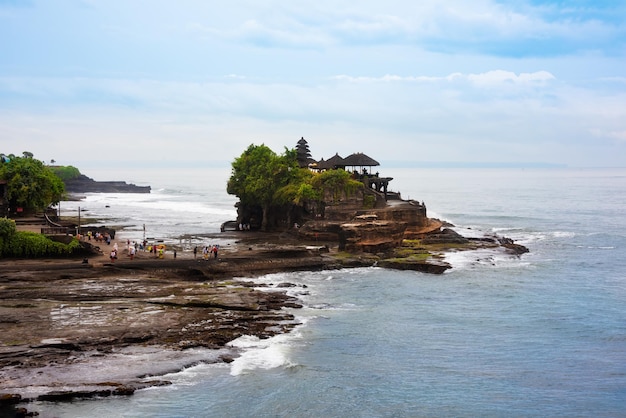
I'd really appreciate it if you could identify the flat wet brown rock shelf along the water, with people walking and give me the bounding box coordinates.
[0,230,527,414]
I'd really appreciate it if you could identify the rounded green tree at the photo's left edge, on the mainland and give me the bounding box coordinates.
[0,152,65,211]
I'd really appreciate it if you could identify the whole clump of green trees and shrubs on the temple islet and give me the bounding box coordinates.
[226,144,363,231]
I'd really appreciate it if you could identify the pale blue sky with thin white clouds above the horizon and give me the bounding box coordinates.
[0,0,626,168]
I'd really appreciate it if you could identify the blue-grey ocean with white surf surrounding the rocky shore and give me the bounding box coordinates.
[27,167,626,418]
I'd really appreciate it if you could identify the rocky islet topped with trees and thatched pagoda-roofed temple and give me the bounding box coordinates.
[222,138,528,274]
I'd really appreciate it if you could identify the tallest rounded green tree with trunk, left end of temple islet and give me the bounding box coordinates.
[226,144,299,231]
